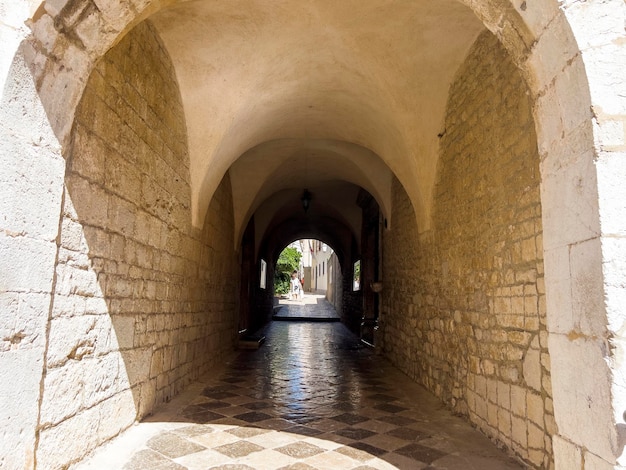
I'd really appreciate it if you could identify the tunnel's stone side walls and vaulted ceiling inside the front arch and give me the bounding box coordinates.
[31,0,553,465]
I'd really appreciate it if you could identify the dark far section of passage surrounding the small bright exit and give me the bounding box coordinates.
[240,182,383,341]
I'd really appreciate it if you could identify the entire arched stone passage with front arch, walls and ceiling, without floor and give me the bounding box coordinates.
[0,0,626,468]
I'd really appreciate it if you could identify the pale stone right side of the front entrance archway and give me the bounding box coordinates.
[468,2,624,469]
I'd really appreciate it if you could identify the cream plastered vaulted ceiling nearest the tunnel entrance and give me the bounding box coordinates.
[150,0,484,238]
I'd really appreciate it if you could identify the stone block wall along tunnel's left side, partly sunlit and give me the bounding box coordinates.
[36,22,239,469]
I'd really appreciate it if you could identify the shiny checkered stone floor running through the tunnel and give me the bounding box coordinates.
[80,304,523,470]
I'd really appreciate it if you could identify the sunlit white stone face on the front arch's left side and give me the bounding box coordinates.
[0,53,65,469]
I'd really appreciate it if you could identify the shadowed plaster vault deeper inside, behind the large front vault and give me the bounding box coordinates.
[229,139,391,248]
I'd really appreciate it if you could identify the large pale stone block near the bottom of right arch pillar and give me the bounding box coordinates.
[549,334,617,462]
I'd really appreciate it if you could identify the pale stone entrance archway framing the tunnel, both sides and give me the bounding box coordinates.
[0,0,626,468]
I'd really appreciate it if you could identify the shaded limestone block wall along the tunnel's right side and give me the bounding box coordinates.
[383,32,556,468]
